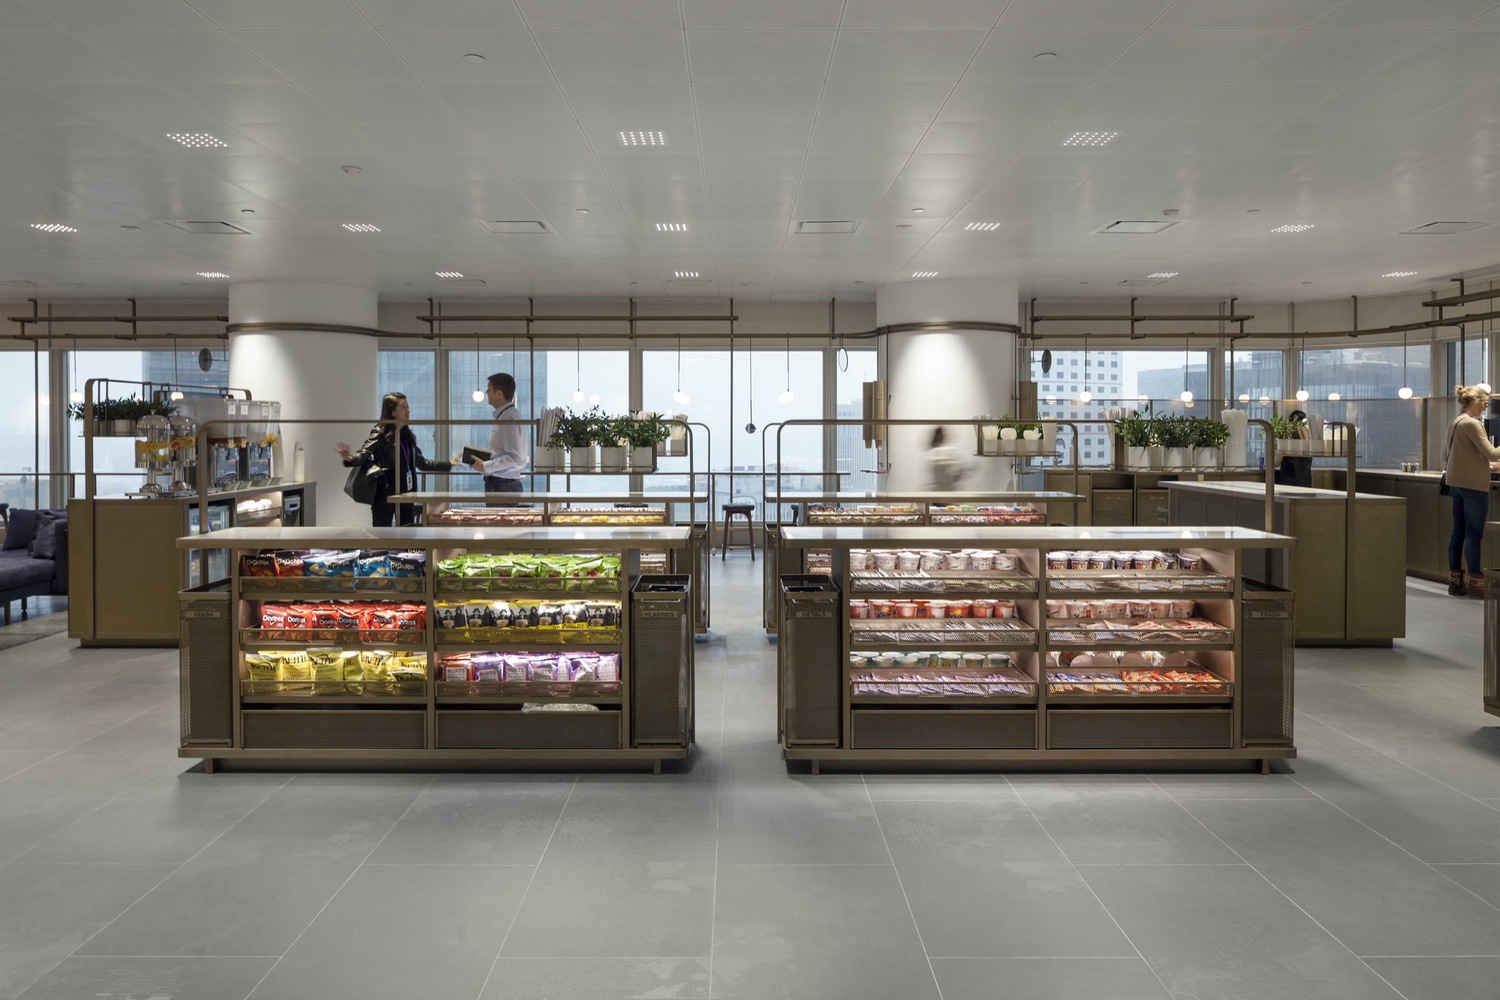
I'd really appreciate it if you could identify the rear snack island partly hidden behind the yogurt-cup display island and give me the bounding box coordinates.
[762,490,1079,633]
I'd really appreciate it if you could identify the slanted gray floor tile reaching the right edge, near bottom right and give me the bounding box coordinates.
[1188,801,1500,955]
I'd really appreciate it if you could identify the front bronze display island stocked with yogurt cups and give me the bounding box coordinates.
[777,526,1296,771]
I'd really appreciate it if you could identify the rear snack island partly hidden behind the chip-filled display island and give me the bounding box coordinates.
[395,492,713,634]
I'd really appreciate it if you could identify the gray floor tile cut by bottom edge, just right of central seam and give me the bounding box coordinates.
[713,867,938,1000]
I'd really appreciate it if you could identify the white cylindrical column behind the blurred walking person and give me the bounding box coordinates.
[875,277,1017,492]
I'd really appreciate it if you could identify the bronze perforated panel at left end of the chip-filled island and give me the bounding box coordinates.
[177,592,234,747]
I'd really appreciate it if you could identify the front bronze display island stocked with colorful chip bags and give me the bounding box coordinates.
[177,526,693,771]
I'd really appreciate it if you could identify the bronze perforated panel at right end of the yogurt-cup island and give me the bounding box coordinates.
[1236,591,1298,747]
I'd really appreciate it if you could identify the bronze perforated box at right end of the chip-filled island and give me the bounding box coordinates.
[630,576,693,747]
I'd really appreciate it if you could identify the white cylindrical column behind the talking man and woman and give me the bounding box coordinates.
[230,282,380,528]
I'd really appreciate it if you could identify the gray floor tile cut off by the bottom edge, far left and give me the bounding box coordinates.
[10,957,276,1000]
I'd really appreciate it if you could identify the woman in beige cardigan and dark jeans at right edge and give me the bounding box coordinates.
[1443,385,1500,598]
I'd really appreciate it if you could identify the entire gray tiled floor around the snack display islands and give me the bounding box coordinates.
[0,563,1500,1000]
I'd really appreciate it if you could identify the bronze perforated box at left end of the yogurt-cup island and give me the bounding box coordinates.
[776,576,845,747]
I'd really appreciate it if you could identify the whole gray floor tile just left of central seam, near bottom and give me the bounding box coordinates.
[501,844,714,958]
